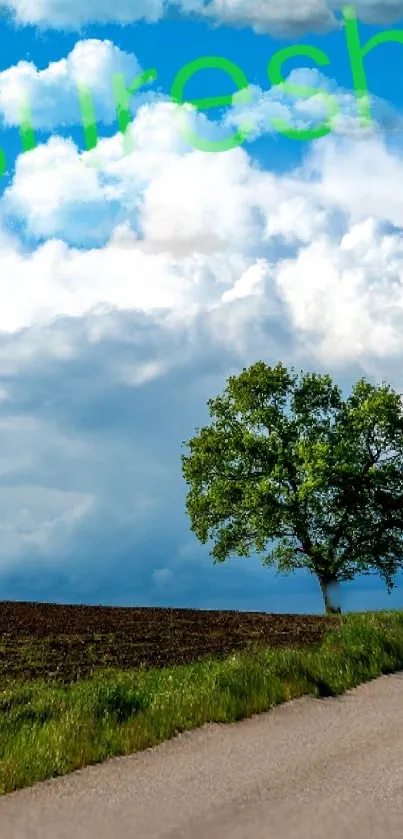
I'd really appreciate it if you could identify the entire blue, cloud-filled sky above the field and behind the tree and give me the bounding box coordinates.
[0,0,403,613]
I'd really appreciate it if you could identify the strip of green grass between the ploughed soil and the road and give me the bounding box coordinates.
[0,611,403,794]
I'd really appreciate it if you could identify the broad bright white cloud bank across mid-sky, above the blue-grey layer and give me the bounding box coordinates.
[0,94,403,364]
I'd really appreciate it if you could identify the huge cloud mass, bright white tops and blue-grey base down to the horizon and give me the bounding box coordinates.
[0,77,403,608]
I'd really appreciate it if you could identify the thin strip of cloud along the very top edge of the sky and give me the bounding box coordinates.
[1,0,403,37]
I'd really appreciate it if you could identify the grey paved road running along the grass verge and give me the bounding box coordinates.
[0,673,403,839]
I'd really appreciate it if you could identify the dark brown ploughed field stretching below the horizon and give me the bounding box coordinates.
[0,601,340,685]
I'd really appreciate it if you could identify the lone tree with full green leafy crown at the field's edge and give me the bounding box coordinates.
[181,361,403,613]
